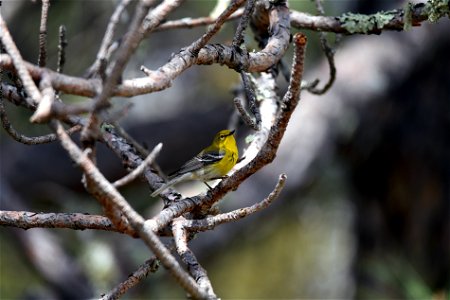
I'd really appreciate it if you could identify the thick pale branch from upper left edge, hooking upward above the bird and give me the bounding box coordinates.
[0,0,290,97]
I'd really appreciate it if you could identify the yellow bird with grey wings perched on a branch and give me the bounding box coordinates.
[152,130,239,197]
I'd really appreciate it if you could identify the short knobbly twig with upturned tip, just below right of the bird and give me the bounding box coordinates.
[184,174,286,232]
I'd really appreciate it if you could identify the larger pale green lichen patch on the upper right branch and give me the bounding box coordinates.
[338,10,396,33]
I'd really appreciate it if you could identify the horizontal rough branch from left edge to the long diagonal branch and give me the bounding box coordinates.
[0,211,123,233]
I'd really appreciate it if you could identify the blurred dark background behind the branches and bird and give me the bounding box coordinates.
[0,0,450,299]
